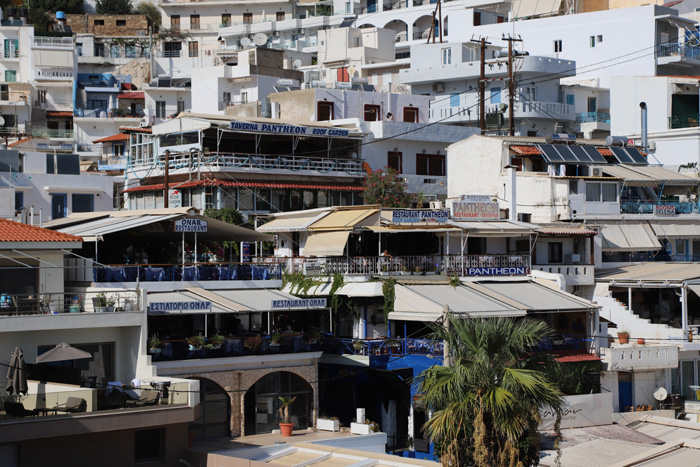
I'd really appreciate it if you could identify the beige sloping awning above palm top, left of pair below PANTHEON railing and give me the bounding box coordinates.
[389,285,526,322]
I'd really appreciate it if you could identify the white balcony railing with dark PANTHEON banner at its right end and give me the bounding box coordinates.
[274,254,530,276]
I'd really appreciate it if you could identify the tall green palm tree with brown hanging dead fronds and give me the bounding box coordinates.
[416,315,563,467]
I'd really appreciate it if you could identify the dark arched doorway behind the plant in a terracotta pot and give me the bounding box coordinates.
[244,371,314,435]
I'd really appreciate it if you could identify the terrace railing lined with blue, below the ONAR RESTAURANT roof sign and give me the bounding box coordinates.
[93,263,282,282]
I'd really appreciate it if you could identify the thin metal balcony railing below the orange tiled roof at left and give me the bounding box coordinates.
[0,290,142,317]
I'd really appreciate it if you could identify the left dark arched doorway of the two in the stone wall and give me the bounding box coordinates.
[190,378,231,439]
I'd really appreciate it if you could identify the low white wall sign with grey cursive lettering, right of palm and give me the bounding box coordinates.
[537,392,613,431]
